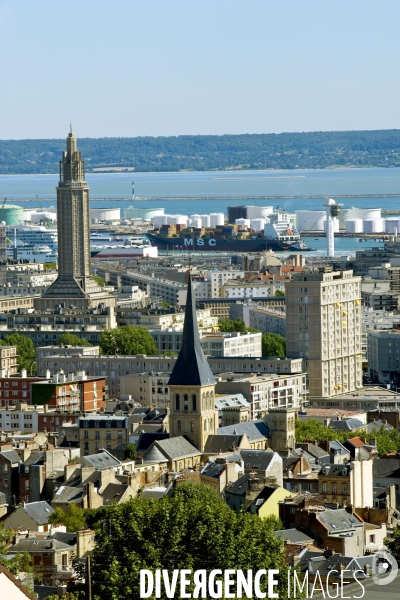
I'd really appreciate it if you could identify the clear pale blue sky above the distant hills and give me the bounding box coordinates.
[0,0,400,139]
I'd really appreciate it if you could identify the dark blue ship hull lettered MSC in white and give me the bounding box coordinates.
[146,233,293,252]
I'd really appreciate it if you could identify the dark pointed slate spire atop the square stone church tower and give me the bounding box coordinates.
[168,273,216,385]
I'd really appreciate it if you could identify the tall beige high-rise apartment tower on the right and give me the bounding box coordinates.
[286,271,362,397]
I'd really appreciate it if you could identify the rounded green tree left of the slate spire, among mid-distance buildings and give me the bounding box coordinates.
[100,325,158,356]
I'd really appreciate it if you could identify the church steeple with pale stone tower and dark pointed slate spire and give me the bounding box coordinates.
[168,274,217,452]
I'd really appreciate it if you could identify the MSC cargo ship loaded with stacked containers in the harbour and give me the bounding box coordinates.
[146,213,314,252]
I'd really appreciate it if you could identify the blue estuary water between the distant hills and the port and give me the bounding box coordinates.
[0,168,400,255]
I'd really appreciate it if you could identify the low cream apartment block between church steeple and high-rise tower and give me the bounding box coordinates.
[215,373,306,420]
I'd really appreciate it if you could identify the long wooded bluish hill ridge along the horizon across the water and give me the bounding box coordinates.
[0,129,400,174]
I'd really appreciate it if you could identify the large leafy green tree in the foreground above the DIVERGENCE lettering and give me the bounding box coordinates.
[88,482,288,600]
